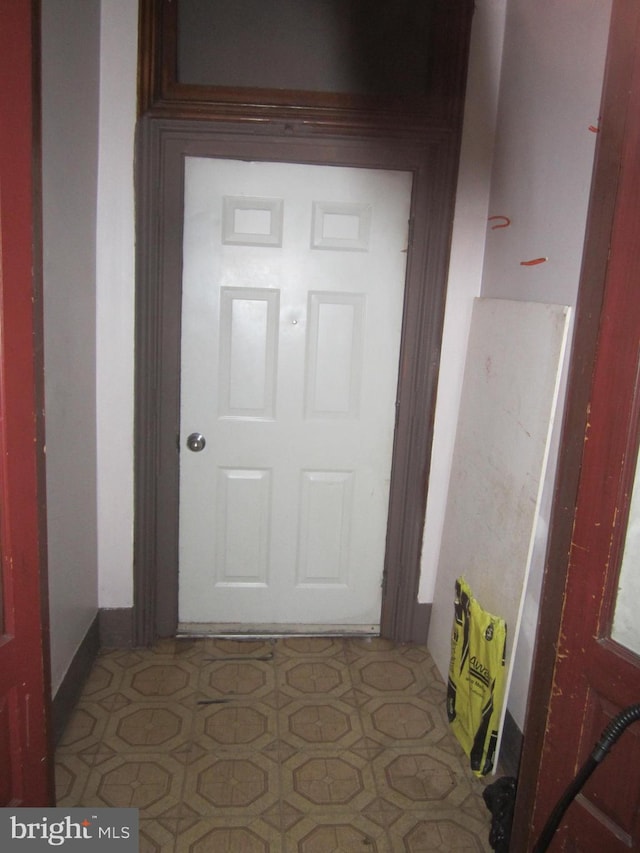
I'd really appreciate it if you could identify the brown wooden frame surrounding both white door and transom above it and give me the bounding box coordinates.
[134,0,474,644]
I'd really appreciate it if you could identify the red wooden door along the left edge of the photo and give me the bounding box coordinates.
[0,0,54,807]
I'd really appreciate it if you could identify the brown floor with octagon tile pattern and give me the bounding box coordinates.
[56,638,493,853]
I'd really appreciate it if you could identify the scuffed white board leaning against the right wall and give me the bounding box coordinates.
[429,298,570,764]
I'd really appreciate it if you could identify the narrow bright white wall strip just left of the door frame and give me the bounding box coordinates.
[96,0,138,608]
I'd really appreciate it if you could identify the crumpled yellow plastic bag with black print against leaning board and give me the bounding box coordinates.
[447,578,507,776]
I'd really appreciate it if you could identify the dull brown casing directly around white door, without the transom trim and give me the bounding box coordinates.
[135,118,459,644]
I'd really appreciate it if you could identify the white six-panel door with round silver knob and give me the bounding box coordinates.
[179,157,411,631]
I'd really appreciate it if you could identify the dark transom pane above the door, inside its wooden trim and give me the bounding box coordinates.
[173,0,434,98]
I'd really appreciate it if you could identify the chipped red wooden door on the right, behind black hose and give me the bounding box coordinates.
[516,0,640,851]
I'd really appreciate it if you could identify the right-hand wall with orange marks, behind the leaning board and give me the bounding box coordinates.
[424,0,610,728]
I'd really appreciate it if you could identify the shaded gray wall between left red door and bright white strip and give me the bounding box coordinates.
[42,0,100,694]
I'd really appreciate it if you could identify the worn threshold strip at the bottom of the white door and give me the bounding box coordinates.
[176,622,380,640]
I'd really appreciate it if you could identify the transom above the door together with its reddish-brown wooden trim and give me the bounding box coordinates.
[140,0,473,130]
